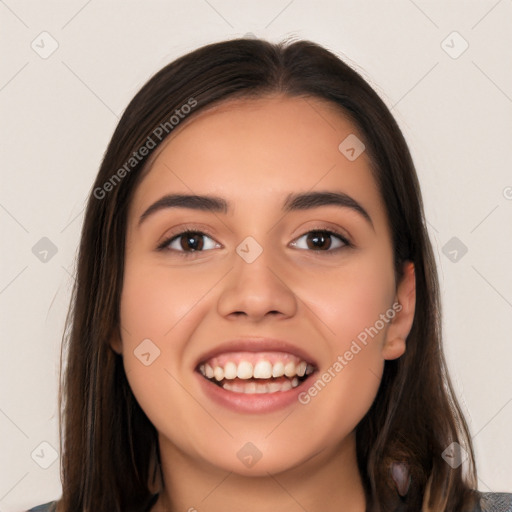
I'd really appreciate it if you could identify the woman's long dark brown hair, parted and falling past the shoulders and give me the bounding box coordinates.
[58,39,477,512]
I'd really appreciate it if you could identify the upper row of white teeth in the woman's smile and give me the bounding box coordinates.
[199,360,313,381]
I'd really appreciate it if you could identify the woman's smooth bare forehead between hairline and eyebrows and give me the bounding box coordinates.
[128,96,382,223]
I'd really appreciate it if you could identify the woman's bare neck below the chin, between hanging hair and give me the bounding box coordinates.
[151,433,366,512]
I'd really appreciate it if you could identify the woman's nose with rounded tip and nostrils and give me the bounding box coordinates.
[218,242,297,322]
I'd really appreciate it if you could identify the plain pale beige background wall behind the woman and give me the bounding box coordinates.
[0,0,512,512]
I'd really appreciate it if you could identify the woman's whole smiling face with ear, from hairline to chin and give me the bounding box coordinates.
[112,97,414,475]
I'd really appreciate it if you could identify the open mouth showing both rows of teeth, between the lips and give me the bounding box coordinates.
[197,352,316,394]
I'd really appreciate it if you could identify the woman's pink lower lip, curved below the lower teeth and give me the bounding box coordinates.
[197,372,313,414]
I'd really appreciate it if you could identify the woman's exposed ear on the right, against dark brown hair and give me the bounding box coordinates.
[382,261,416,359]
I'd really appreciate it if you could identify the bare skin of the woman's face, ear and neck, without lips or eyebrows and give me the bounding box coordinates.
[112,96,415,512]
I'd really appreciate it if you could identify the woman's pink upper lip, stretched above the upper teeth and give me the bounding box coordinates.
[196,337,317,369]
